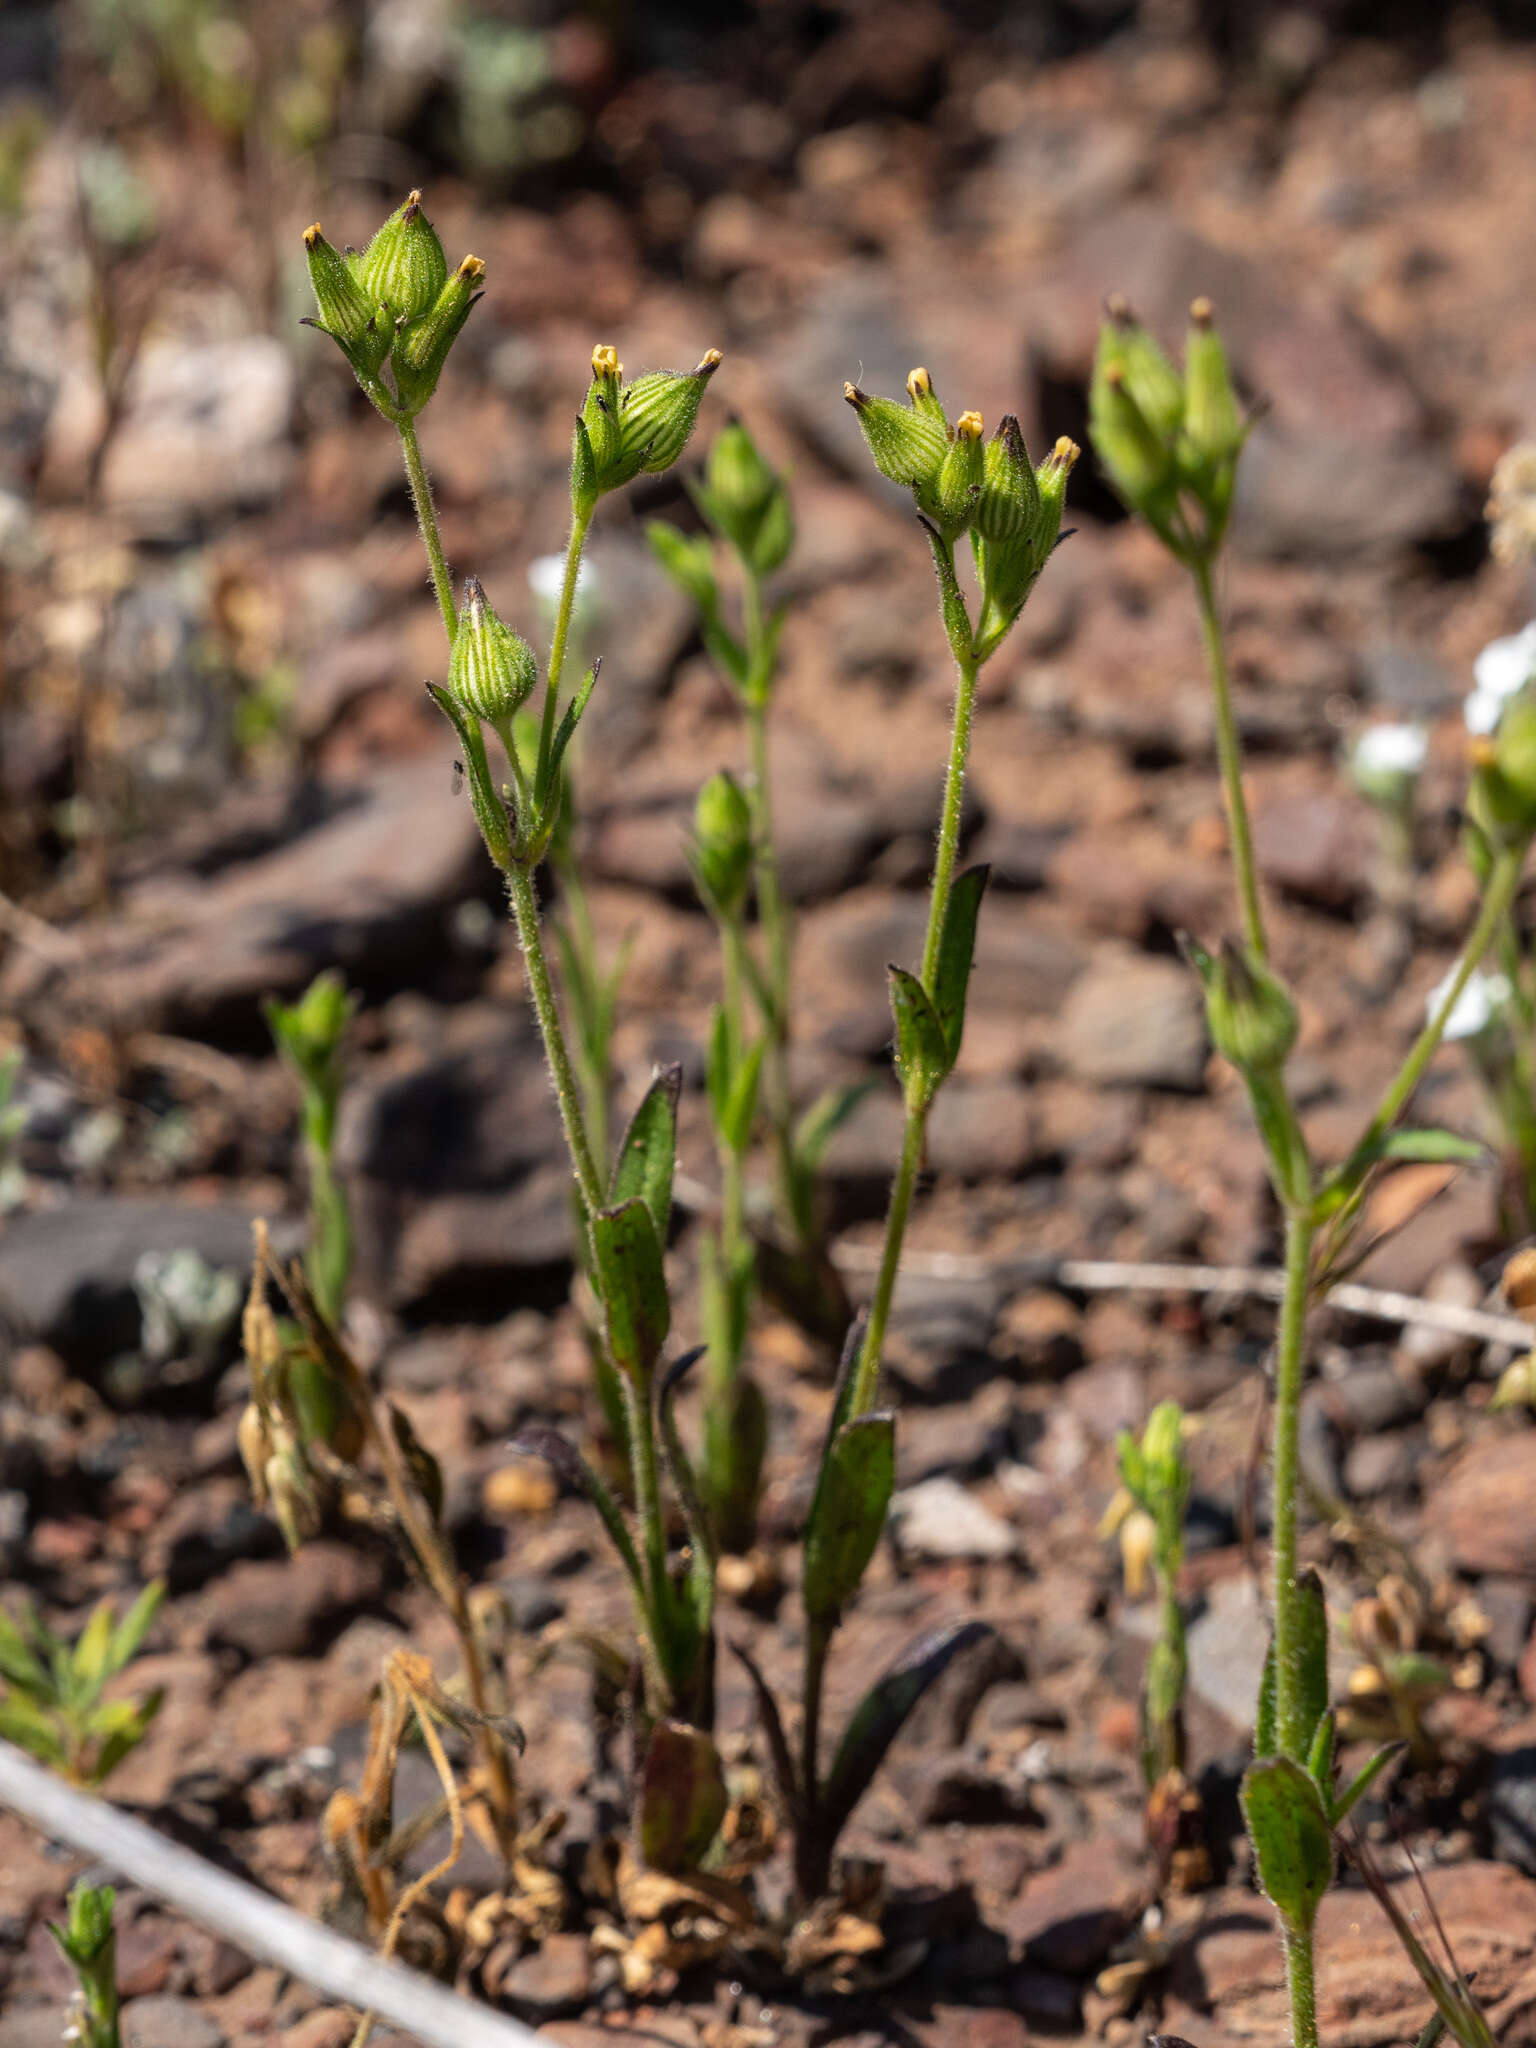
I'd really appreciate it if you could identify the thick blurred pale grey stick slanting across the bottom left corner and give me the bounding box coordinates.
[0,1741,547,2048]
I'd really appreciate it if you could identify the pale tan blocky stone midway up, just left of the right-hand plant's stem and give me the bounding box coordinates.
[1055,952,1206,1092]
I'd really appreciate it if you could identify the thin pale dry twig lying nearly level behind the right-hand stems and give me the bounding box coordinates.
[836,1245,1536,1350]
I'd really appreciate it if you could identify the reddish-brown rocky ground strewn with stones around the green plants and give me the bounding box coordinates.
[0,0,1536,2048]
